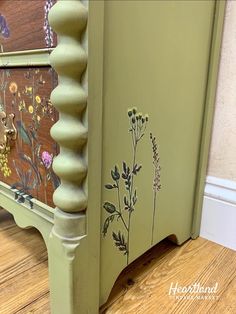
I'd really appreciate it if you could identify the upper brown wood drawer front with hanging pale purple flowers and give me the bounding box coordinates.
[0,0,56,52]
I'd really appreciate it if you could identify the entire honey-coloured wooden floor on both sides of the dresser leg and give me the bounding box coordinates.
[0,210,236,314]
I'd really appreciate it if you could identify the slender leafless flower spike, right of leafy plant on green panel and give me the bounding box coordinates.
[150,133,161,244]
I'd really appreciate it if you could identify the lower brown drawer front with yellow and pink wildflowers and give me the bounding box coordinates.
[0,67,59,207]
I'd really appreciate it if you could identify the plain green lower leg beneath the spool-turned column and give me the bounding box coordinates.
[48,210,99,314]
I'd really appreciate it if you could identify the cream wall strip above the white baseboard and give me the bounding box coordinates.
[208,0,236,181]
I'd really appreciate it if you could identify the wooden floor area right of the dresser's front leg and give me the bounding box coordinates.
[100,238,236,314]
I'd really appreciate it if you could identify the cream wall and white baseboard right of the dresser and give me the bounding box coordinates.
[200,0,236,250]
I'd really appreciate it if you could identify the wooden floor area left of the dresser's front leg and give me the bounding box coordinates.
[0,209,50,314]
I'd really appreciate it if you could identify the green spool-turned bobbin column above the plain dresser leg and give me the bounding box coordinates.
[49,0,88,213]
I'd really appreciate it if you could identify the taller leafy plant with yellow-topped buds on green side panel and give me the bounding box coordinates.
[102,108,148,264]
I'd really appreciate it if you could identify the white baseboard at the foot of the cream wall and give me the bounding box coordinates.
[200,177,236,250]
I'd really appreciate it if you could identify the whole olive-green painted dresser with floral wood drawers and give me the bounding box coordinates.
[0,0,225,314]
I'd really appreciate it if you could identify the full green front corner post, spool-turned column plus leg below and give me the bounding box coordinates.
[48,0,99,314]
